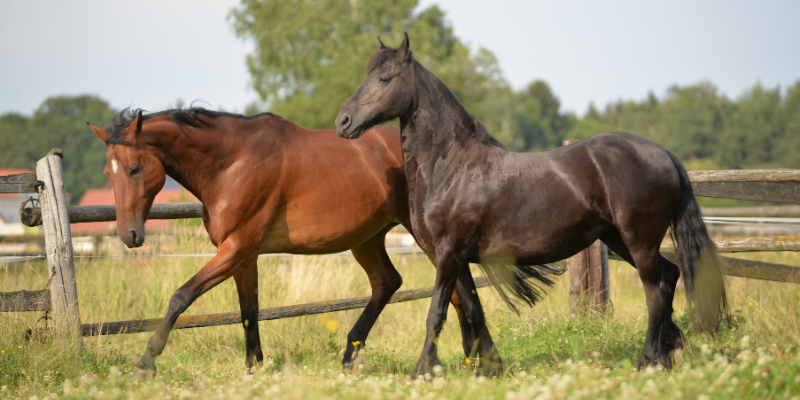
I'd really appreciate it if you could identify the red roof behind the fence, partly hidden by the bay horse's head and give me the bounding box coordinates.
[70,189,197,234]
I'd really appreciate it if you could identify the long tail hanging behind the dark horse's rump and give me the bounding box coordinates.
[667,151,728,332]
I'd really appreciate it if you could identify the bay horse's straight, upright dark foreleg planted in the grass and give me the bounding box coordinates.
[233,262,264,370]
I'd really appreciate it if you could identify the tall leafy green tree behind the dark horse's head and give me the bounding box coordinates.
[229,0,510,138]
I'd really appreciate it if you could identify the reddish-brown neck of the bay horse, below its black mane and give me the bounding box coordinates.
[142,120,233,201]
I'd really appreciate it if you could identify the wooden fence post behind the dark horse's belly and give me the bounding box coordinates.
[564,140,610,314]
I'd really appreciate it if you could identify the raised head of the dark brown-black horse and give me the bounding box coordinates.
[336,33,415,139]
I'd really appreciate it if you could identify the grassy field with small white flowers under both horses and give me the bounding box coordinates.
[0,228,800,399]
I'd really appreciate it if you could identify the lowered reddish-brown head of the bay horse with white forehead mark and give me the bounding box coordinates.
[89,110,166,247]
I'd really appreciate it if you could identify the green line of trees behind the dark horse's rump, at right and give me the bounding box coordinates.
[567,82,800,168]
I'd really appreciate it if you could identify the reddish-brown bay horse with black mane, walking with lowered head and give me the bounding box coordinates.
[90,108,500,373]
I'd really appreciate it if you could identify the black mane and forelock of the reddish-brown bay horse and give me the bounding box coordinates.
[106,107,280,145]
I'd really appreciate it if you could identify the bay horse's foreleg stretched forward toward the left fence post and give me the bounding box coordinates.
[136,237,257,374]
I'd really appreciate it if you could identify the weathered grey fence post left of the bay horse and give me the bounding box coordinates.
[36,149,83,348]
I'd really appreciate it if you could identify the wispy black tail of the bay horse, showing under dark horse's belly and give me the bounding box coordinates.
[478,264,564,315]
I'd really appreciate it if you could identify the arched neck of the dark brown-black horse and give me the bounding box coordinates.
[400,62,490,173]
